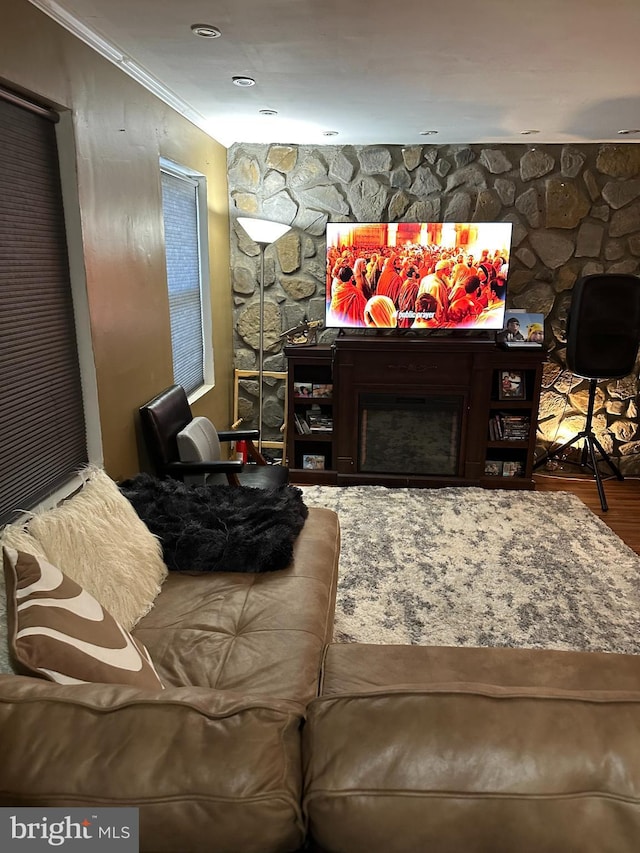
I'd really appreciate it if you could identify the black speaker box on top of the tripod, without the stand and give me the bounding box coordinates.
[567,273,640,379]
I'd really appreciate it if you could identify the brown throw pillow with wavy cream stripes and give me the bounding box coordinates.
[3,548,163,690]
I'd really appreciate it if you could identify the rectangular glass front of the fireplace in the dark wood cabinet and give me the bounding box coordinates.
[358,394,464,477]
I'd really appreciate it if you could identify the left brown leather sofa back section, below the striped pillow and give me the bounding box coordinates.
[0,676,304,853]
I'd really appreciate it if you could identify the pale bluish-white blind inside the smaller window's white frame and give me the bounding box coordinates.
[162,172,204,393]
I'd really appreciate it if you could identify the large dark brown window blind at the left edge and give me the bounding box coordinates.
[0,91,87,524]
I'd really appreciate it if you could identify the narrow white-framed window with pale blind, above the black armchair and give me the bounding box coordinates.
[160,160,213,394]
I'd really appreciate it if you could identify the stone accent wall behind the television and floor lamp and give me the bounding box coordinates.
[228,143,640,474]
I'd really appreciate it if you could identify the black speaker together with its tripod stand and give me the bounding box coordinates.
[533,274,640,512]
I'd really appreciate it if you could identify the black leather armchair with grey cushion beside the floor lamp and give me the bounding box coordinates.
[140,385,289,489]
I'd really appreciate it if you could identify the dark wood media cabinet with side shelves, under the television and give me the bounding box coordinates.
[285,335,545,489]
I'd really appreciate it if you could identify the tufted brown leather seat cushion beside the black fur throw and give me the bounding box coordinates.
[134,507,340,704]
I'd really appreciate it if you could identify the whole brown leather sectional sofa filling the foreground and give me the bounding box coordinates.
[0,470,640,853]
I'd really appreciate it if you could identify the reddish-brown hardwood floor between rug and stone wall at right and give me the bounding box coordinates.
[534,473,640,554]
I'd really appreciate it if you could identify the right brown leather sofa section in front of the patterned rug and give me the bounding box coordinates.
[303,643,640,853]
